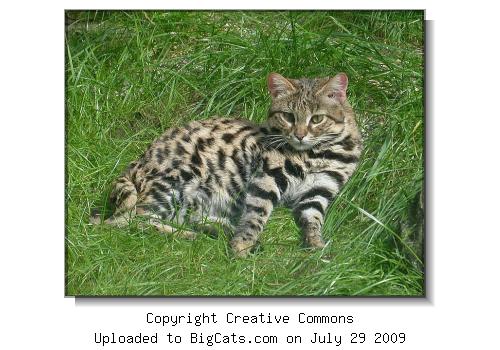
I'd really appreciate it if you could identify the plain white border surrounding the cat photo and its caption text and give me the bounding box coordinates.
[0,0,500,349]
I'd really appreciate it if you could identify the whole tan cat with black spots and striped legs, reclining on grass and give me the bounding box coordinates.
[92,73,362,256]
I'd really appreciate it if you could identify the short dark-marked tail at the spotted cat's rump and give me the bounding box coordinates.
[90,174,137,226]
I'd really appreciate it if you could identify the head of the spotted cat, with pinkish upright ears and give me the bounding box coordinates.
[267,73,351,151]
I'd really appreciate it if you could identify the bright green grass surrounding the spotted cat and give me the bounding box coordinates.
[65,11,424,296]
